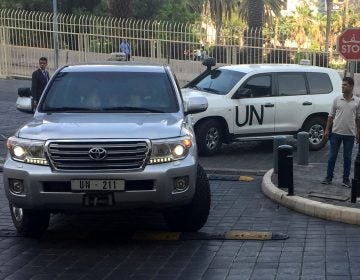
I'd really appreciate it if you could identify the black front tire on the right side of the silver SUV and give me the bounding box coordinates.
[163,165,211,232]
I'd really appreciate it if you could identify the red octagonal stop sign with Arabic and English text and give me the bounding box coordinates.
[336,28,360,60]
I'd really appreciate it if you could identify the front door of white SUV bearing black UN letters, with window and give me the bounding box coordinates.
[233,73,275,136]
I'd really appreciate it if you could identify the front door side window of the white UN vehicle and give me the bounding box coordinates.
[241,74,272,98]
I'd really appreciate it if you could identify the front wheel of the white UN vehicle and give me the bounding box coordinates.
[195,119,223,156]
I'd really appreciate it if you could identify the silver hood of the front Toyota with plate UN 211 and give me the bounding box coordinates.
[17,113,183,140]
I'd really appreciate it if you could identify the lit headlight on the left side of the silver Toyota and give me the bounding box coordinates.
[6,137,49,165]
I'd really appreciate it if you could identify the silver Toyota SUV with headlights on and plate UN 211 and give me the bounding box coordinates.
[3,63,210,236]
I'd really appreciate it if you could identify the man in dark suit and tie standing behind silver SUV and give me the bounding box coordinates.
[31,57,50,107]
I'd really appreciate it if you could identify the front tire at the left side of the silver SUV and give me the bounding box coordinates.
[9,204,50,237]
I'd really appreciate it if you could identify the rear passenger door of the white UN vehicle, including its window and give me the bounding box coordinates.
[275,72,315,133]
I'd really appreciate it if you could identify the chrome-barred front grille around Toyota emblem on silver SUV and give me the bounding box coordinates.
[47,140,150,171]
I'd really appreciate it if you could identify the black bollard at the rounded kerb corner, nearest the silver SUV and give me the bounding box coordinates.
[278,145,294,196]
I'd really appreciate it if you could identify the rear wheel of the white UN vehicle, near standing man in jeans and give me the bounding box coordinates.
[302,117,326,151]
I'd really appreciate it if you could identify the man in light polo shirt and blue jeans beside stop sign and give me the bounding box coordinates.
[321,77,360,188]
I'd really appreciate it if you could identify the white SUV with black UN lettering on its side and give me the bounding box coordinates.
[182,58,341,156]
